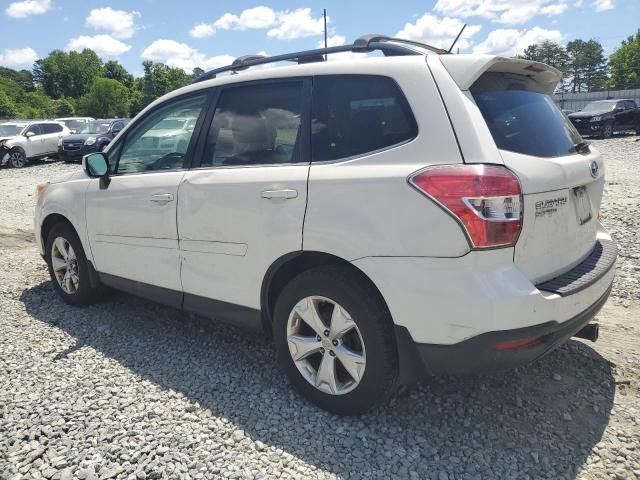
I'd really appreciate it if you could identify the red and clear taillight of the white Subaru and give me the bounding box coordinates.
[409,164,522,248]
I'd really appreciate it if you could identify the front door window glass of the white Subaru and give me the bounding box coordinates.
[116,95,207,175]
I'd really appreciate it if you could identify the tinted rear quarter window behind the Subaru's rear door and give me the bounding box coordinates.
[311,75,418,162]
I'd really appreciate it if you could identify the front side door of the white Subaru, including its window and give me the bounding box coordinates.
[86,94,207,296]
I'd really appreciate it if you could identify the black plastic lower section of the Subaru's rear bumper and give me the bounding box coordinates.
[403,288,611,376]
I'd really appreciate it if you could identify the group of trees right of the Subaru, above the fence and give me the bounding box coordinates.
[520,30,640,93]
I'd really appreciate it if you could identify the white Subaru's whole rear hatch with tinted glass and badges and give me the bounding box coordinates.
[471,72,604,283]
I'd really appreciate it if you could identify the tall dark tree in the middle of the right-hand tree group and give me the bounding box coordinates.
[567,39,607,93]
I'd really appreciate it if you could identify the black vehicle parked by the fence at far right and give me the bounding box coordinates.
[567,99,640,138]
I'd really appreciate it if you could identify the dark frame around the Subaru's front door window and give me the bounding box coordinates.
[108,87,215,177]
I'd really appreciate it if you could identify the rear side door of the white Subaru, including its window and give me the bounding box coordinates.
[178,79,310,321]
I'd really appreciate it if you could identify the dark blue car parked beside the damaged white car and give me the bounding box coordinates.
[58,118,129,162]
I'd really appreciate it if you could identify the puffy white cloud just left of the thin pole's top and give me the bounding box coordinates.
[189,6,330,40]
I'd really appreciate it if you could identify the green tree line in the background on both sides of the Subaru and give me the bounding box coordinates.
[0,30,640,118]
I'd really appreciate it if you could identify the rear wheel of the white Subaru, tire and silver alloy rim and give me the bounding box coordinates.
[273,266,398,415]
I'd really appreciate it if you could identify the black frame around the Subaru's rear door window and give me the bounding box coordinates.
[189,77,312,170]
